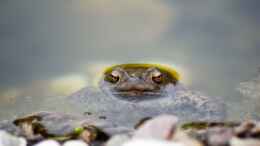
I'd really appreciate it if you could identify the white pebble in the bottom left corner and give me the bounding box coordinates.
[0,131,27,146]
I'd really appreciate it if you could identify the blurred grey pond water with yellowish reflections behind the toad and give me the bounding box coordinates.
[0,0,260,120]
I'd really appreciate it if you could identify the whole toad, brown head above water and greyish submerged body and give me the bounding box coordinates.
[69,64,225,125]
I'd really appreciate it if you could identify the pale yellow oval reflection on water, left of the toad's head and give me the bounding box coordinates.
[50,75,87,95]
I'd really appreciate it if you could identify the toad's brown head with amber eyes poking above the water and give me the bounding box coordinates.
[100,64,179,101]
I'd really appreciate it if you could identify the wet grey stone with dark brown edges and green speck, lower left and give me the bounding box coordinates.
[2,112,109,145]
